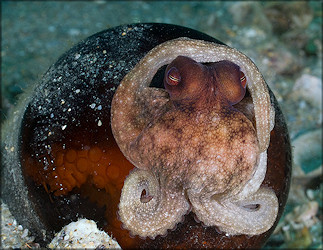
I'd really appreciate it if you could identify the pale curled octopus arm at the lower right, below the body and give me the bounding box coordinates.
[188,188,278,235]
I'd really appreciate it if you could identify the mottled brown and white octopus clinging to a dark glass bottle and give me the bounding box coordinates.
[111,38,278,239]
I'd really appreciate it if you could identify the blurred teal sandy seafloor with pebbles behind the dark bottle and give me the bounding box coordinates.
[1,1,322,249]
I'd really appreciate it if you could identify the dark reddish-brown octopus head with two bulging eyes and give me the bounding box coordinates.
[164,56,246,105]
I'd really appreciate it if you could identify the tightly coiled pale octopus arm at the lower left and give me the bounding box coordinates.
[119,169,190,239]
